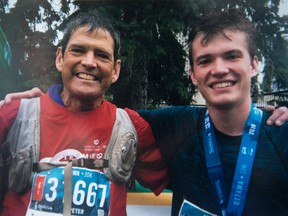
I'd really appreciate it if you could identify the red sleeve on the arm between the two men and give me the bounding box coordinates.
[125,108,169,195]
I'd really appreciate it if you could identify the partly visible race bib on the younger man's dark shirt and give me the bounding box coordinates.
[179,200,217,216]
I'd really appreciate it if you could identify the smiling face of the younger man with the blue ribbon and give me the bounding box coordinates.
[190,30,258,108]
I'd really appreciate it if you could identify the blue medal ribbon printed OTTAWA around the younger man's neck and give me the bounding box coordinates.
[203,105,262,216]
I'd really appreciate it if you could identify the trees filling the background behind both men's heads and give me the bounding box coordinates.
[0,0,288,109]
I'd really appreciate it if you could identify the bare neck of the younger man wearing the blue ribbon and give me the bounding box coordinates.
[207,102,251,136]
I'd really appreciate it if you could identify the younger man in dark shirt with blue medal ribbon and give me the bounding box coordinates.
[141,9,288,216]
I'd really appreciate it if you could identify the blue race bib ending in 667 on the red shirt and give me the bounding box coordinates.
[26,167,110,216]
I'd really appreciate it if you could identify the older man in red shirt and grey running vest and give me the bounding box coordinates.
[0,11,168,216]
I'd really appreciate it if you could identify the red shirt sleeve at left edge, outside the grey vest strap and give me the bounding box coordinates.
[0,100,20,145]
